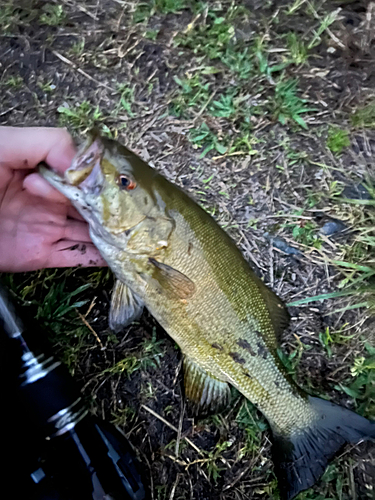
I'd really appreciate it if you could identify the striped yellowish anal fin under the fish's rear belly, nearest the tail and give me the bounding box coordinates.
[184,356,231,414]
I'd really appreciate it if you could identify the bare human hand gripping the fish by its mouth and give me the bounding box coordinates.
[0,127,107,272]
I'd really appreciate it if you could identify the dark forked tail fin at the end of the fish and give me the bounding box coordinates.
[272,397,375,500]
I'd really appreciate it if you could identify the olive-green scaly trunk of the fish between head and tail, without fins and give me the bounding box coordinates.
[117,197,314,433]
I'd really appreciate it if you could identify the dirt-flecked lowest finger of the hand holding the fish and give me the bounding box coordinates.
[45,240,107,267]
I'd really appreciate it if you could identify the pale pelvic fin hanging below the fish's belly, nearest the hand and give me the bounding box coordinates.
[109,280,144,333]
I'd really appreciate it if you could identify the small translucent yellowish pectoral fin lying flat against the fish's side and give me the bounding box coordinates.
[149,258,195,299]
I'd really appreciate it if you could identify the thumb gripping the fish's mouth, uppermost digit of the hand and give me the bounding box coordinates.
[0,127,76,172]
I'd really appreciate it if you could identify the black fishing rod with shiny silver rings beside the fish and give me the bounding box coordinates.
[0,288,146,500]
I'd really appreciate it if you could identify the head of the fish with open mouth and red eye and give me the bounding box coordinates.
[39,133,176,253]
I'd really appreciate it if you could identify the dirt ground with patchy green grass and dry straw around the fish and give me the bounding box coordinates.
[0,0,375,500]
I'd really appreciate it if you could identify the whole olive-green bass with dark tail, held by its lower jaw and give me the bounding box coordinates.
[39,133,375,500]
